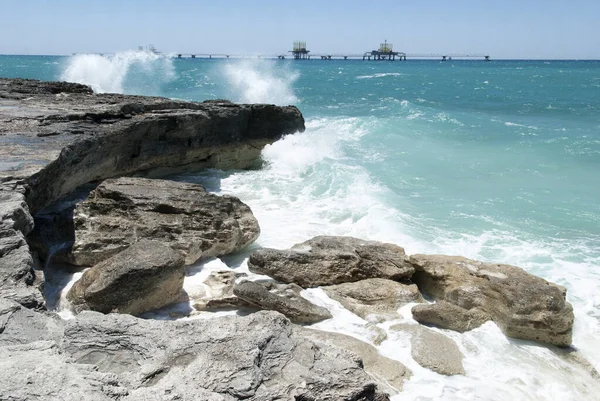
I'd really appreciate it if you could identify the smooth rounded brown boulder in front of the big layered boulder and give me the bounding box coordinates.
[67,240,185,315]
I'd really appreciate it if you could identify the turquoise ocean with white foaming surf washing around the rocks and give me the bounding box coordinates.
[0,52,600,401]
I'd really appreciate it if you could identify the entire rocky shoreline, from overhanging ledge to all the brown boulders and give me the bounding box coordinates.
[0,79,574,401]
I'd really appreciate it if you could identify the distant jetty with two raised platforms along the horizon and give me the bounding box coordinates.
[176,40,490,61]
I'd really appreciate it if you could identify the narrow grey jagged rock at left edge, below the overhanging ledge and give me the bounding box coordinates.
[0,189,44,309]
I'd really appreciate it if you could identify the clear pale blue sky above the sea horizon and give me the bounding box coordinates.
[0,0,600,59]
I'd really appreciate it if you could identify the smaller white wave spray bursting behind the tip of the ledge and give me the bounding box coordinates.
[223,60,299,106]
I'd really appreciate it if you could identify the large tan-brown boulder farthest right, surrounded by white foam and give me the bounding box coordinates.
[410,255,574,347]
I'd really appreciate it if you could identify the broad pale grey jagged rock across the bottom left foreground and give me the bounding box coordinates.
[0,302,388,401]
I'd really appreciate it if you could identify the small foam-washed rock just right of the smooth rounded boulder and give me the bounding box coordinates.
[193,270,248,311]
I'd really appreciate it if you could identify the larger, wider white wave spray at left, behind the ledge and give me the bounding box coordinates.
[61,51,175,94]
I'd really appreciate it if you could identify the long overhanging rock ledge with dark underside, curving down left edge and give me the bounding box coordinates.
[0,78,304,308]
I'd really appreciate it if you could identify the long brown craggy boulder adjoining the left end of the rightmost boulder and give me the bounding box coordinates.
[248,236,414,288]
